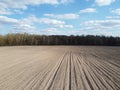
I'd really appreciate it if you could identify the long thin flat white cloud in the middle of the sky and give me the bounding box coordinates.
[44,13,79,19]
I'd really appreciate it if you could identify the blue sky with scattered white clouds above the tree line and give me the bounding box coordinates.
[0,0,120,36]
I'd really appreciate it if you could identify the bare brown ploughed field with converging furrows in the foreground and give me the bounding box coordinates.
[0,46,120,90]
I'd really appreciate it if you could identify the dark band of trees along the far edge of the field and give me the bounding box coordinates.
[0,33,120,46]
